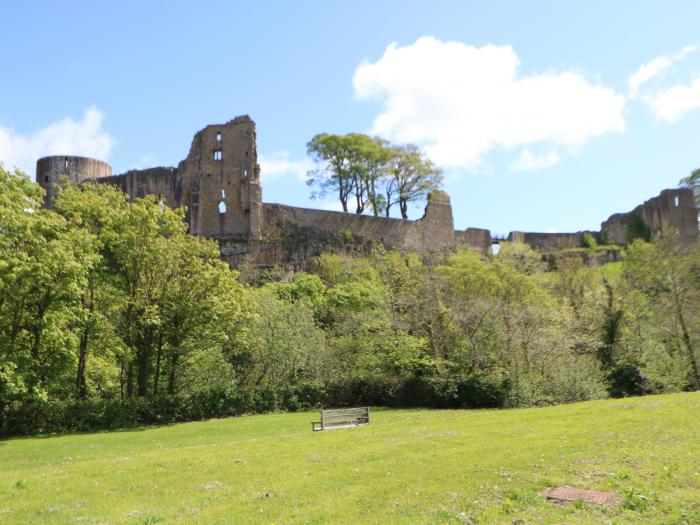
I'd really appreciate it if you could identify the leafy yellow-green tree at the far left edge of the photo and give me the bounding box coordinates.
[0,165,96,423]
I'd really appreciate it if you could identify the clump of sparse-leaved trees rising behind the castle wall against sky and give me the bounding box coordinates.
[307,133,442,219]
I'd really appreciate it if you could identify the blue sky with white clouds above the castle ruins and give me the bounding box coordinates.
[0,0,700,233]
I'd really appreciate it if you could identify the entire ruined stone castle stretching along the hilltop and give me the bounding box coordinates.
[36,116,698,268]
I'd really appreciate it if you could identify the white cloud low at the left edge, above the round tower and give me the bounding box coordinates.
[0,106,114,179]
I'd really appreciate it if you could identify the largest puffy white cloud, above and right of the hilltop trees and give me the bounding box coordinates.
[353,37,625,172]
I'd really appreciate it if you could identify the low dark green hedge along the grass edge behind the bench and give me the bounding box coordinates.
[0,376,508,437]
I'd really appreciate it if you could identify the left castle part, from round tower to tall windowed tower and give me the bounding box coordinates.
[36,116,262,242]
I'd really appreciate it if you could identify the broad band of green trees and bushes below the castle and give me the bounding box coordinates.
[0,169,700,435]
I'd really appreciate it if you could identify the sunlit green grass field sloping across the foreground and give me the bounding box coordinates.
[0,393,700,525]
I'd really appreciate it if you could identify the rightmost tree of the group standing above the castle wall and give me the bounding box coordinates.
[384,144,442,219]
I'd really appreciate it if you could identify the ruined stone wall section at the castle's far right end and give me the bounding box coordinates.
[601,188,698,246]
